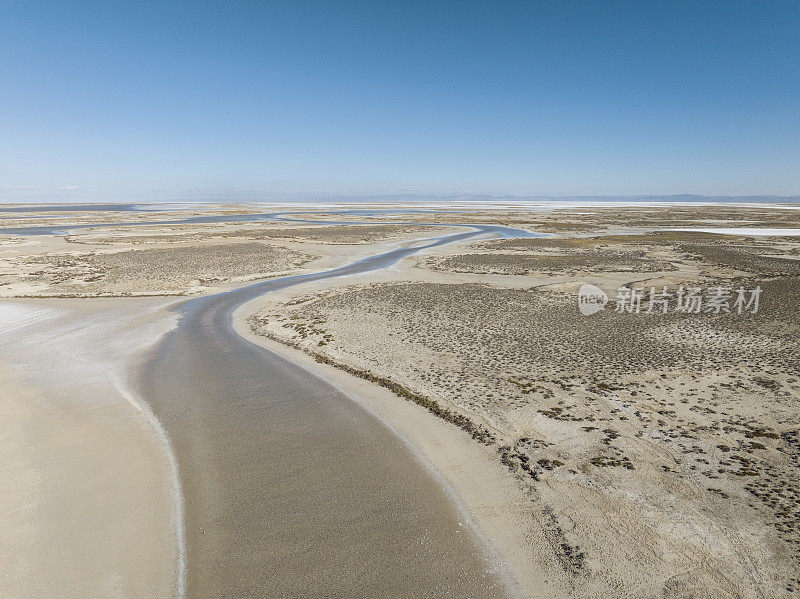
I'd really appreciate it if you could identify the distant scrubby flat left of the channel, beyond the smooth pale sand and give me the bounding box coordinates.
[0,212,441,297]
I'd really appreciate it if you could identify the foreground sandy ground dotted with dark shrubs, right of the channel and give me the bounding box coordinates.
[251,277,800,596]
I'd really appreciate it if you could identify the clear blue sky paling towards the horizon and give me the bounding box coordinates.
[0,0,800,201]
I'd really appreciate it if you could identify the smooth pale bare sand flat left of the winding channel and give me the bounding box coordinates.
[0,298,181,598]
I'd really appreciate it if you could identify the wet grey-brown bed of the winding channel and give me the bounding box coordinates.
[135,227,511,597]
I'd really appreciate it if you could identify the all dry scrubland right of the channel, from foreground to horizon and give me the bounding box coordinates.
[250,220,800,597]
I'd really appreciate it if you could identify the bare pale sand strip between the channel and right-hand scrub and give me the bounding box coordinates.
[235,322,569,599]
